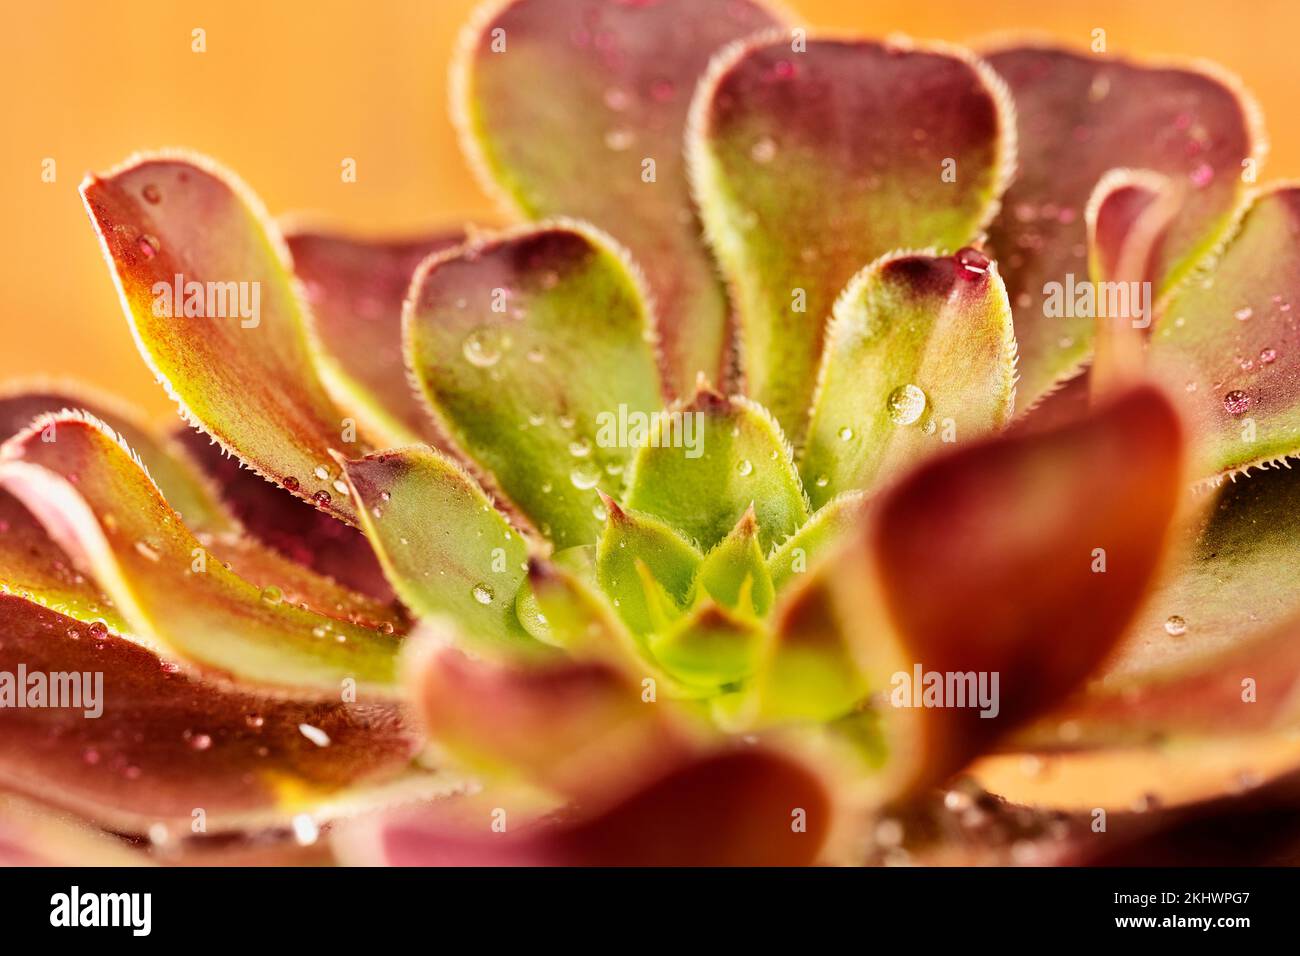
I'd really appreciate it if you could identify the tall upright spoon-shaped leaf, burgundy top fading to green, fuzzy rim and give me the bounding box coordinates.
[686,35,1014,444]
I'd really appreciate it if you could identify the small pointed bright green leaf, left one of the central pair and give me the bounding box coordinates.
[595,498,701,635]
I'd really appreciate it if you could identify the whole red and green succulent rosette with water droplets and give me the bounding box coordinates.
[0,0,1300,864]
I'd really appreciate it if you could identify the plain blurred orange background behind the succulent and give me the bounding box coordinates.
[0,0,1300,414]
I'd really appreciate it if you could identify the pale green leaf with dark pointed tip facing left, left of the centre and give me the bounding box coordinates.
[343,446,529,643]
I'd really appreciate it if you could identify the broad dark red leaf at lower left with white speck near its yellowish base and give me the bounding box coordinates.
[0,596,446,832]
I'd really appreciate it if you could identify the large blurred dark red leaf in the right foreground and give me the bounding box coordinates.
[857,386,1183,780]
